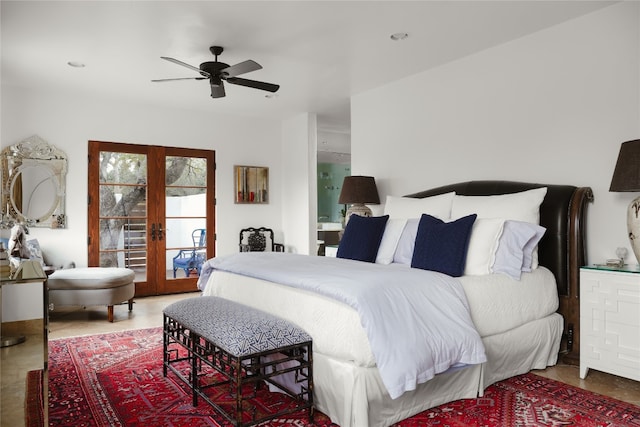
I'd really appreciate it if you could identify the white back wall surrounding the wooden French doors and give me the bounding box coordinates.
[0,86,284,266]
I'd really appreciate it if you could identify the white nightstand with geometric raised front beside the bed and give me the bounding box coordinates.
[580,265,640,381]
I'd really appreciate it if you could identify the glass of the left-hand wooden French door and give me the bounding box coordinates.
[99,151,147,281]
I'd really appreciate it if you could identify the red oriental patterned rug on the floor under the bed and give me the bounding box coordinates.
[26,328,640,427]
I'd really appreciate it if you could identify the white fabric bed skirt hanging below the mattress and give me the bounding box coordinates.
[313,314,562,427]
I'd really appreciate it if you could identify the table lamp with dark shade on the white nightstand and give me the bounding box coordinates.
[609,139,640,263]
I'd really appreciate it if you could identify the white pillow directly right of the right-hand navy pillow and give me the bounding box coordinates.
[464,218,504,275]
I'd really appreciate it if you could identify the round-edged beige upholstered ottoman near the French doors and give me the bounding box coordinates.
[47,267,136,322]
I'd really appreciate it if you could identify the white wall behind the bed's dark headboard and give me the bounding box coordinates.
[351,2,640,262]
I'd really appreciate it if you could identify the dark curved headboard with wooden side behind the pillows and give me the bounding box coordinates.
[407,181,593,364]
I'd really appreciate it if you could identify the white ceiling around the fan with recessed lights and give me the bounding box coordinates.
[0,0,612,137]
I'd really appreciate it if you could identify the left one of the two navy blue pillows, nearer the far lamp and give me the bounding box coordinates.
[336,215,389,262]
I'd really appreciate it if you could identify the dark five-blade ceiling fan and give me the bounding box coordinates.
[151,46,280,98]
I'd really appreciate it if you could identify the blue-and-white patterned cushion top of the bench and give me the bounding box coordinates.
[163,296,311,357]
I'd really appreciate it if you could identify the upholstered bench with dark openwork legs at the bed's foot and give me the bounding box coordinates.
[163,296,313,427]
